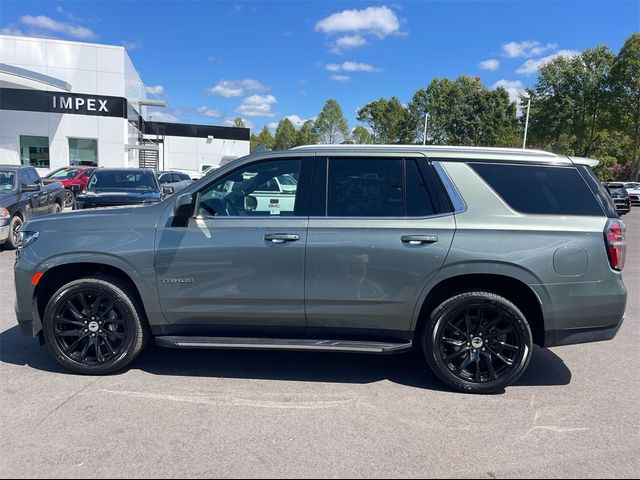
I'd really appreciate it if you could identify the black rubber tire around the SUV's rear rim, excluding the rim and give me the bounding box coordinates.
[422,292,533,393]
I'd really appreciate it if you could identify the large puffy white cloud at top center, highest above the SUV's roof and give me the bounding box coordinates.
[316,6,400,38]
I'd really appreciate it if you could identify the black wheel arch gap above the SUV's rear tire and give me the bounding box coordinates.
[414,273,545,346]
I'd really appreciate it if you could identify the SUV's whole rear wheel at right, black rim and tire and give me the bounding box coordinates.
[420,291,533,393]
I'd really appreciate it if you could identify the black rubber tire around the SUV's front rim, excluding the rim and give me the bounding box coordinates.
[43,279,140,375]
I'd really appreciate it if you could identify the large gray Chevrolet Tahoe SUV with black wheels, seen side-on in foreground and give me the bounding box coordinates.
[15,146,627,393]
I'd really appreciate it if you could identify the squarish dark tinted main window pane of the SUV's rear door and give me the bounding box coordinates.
[327,158,404,217]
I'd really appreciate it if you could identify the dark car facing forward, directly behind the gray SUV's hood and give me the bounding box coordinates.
[73,168,173,210]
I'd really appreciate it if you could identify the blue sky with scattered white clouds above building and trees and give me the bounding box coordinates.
[0,0,640,131]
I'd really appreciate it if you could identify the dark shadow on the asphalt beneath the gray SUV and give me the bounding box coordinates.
[0,326,571,391]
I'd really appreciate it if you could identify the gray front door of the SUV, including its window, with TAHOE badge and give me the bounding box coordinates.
[156,157,313,331]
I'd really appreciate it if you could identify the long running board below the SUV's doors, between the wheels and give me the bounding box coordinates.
[156,336,413,353]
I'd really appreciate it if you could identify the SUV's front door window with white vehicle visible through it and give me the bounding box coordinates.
[198,159,302,217]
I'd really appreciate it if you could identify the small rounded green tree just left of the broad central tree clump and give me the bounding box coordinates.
[358,97,415,144]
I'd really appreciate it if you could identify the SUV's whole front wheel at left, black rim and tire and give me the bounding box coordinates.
[43,277,148,375]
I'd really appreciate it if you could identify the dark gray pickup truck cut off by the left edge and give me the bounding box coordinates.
[0,165,64,249]
